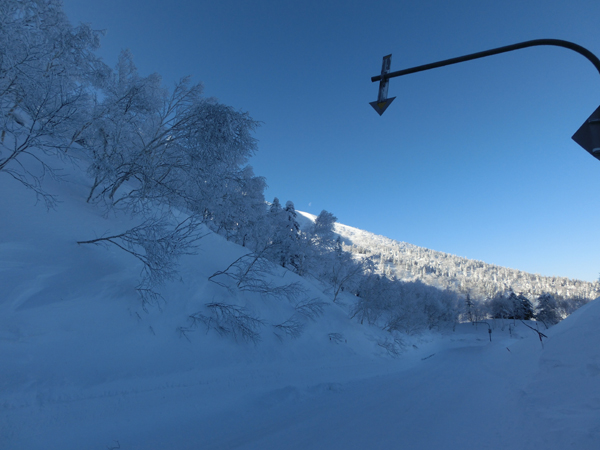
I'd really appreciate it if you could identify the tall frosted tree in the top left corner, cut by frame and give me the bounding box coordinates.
[0,0,107,207]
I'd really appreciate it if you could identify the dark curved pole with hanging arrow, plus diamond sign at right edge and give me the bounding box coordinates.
[371,39,600,160]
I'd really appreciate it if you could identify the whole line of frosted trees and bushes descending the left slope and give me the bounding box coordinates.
[0,0,584,345]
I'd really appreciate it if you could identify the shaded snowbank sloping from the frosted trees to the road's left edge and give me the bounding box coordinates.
[0,158,390,449]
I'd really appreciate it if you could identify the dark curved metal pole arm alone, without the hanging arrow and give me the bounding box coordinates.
[371,39,600,82]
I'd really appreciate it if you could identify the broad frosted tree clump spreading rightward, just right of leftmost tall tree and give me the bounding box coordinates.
[84,52,265,225]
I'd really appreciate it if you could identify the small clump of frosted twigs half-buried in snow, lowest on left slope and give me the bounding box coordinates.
[189,302,264,344]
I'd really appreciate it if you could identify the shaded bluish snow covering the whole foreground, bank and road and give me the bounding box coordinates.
[0,174,600,450]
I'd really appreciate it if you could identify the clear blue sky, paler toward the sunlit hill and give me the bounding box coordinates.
[64,0,600,281]
